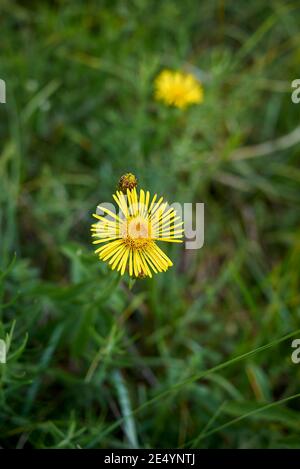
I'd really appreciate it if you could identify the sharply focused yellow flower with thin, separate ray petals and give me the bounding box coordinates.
[91,188,184,277]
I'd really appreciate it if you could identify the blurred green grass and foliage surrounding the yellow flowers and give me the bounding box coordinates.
[0,0,300,448]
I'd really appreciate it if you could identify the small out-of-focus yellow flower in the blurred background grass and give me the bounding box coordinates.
[155,70,203,109]
